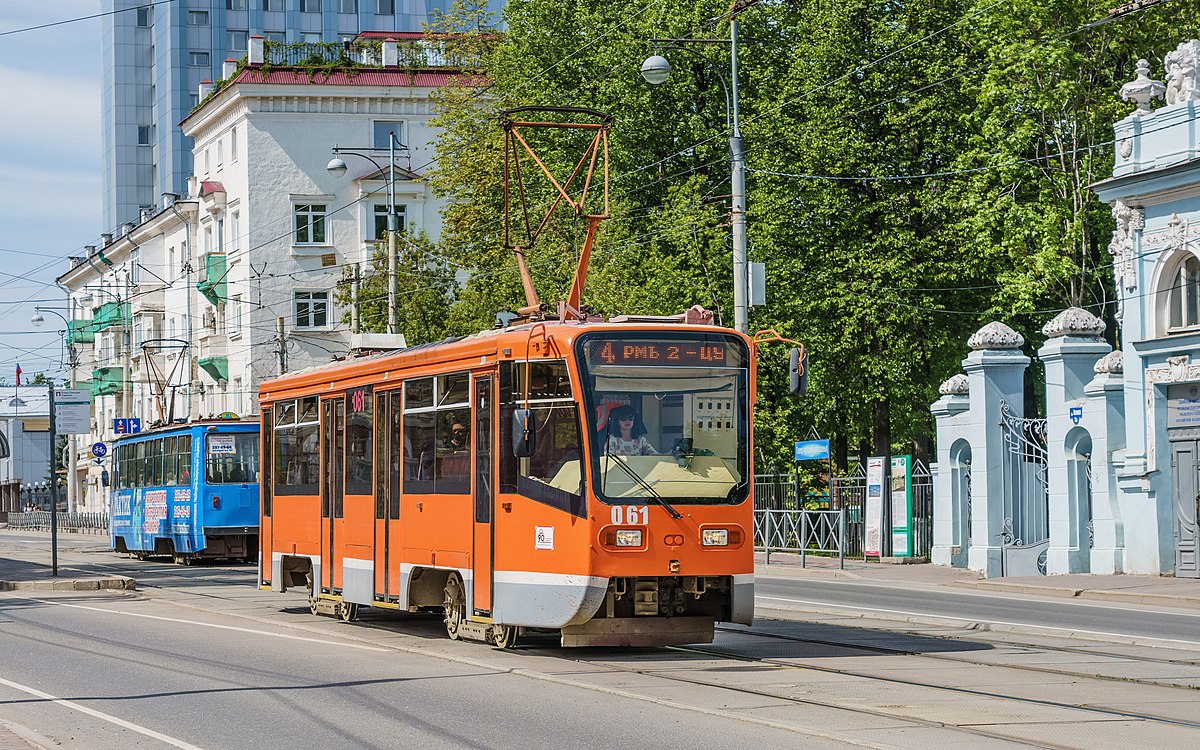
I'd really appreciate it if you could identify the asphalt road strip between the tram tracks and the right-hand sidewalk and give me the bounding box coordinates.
[755,576,1200,646]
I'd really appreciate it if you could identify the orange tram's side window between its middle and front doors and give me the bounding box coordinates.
[404,372,470,494]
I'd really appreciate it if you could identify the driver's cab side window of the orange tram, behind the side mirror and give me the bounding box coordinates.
[500,360,583,512]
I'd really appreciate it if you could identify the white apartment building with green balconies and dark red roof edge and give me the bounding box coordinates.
[59,35,455,510]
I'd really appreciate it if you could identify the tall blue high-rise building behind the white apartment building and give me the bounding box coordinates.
[101,0,503,232]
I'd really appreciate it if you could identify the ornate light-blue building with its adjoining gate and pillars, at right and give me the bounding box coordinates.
[932,40,1200,577]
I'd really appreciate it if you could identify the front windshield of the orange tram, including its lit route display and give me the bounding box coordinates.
[576,331,750,504]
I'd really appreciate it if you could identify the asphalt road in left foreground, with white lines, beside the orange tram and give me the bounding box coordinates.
[0,571,841,750]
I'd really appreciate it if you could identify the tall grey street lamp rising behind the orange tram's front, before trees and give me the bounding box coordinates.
[642,9,757,334]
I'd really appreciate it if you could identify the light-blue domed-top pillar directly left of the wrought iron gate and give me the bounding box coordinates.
[962,322,1030,577]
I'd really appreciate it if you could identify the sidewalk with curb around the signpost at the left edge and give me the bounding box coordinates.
[0,528,137,592]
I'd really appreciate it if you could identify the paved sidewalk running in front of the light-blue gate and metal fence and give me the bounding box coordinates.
[755,552,1200,610]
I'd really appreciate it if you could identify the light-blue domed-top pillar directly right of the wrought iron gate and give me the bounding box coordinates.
[1038,307,1112,575]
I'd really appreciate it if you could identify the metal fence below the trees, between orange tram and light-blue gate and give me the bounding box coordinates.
[754,461,934,559]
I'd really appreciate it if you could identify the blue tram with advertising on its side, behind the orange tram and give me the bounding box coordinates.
[108,420,259,564]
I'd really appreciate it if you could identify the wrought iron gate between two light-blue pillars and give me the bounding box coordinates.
[1000,403,1050,576]
